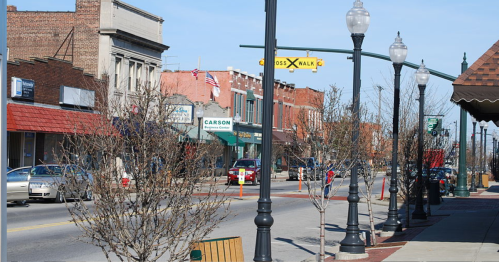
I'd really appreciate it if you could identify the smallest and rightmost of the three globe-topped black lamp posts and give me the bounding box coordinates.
[412,61,430,219]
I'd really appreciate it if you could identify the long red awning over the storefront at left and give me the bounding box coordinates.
[7,103,112,134]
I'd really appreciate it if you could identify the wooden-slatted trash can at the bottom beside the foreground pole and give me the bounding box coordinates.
[190,237,244,262]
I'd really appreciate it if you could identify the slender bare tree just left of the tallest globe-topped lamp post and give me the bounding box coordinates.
[292,86,352,261]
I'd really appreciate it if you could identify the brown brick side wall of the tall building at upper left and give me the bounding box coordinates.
[7,0,100,74]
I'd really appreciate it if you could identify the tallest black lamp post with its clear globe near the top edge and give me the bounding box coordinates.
[340,0,371,254]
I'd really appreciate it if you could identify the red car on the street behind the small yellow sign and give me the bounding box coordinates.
[227,158,262,185]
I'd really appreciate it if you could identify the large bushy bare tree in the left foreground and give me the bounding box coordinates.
[54,82,229,261]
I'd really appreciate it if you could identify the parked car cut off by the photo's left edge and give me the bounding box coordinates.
[7,167,31,205]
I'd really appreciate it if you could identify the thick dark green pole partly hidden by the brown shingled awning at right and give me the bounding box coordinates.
[454,53,470,197]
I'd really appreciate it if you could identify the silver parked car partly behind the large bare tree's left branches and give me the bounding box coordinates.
[29,164,93,203]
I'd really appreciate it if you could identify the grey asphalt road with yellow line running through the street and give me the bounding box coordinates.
[7,176,388,261]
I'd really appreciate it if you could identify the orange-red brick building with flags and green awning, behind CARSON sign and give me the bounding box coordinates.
[161,67,324,170]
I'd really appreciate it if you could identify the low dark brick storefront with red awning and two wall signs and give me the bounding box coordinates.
[7,57,107,168]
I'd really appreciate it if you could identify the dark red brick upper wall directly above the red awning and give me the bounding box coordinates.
[7,58,103,106]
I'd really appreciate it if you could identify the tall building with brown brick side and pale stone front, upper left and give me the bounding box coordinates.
[7,0,168,106]
